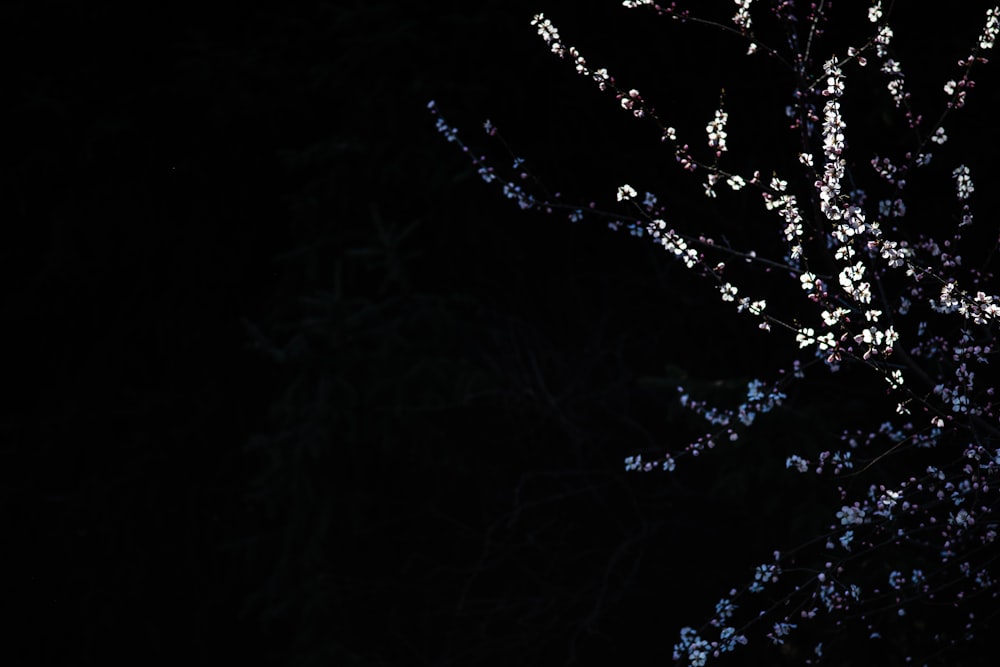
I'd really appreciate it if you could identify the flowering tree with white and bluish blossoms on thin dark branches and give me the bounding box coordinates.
[429,0,1000,667]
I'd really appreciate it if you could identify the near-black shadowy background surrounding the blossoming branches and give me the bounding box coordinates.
[7,0,995,666]
